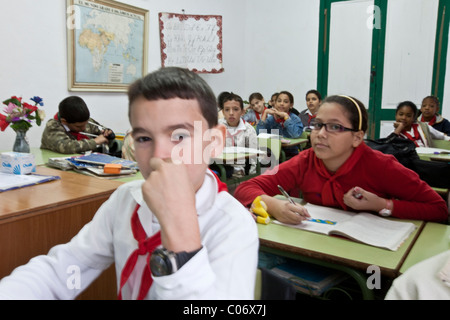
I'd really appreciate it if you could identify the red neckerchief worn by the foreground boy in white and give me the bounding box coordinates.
[118,170,228,300]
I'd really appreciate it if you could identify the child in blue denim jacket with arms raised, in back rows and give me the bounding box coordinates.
[256,91,303,158]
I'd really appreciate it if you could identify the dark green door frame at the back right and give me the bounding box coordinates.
[317,0,450,139]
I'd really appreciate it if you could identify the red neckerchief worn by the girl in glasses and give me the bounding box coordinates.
[313,143,366,210]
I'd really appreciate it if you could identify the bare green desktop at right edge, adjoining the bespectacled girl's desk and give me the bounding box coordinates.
[400,222,450,273]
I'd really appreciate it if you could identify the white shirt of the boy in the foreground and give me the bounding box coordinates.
[0,171,258,300]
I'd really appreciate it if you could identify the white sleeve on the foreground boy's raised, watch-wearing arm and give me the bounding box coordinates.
[150,198,259,300]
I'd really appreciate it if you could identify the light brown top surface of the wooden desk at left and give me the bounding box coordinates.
[0,167,123,224]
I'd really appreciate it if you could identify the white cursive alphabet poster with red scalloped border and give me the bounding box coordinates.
[159,13,223,73]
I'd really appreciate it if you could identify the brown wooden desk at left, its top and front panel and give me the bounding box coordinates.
[0,166,122,299]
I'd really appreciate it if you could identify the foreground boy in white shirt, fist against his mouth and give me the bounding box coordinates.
[0,67,258,300]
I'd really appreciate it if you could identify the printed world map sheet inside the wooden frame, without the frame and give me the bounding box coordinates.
[75,1,145,84]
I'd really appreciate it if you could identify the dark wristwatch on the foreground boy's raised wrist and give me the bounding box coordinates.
[150,247,203,277]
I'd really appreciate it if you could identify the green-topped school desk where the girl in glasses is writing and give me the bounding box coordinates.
[258,212,425,299]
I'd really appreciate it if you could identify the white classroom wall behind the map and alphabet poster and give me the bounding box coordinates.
[0,0,319,150]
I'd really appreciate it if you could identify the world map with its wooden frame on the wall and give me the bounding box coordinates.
[67,0,149,92]
